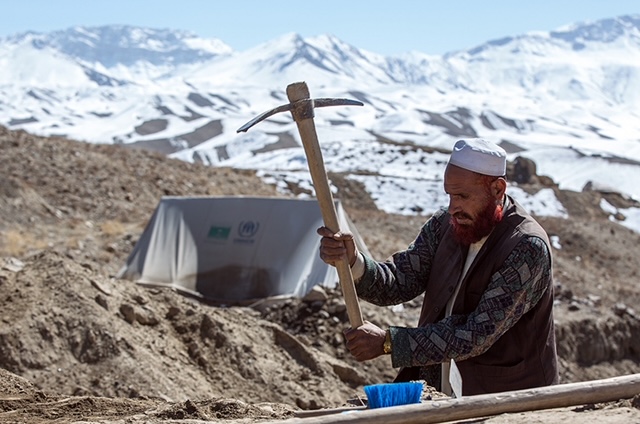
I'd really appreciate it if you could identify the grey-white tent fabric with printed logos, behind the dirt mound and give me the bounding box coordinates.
[118,196,367,303]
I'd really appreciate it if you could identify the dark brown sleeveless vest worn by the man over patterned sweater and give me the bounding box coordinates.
[396,197,558,395]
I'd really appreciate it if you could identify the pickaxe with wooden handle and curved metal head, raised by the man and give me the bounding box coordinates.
[237,82,364,328]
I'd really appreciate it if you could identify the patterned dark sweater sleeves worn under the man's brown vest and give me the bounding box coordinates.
[356,203,551,394]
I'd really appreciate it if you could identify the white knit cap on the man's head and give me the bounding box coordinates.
[449,138,507,177]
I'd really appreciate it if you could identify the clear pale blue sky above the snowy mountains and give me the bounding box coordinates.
[5,0,640,55]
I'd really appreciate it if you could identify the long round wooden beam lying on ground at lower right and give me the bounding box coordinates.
[274,374,640,424]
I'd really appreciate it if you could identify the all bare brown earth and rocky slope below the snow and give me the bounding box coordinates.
[0,127,640,424]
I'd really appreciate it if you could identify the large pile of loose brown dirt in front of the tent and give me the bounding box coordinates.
[0,251,365,408]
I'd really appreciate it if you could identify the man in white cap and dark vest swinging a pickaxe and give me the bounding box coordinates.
[318,139,558,396]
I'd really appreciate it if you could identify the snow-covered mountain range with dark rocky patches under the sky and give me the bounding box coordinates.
[0,15,640,230]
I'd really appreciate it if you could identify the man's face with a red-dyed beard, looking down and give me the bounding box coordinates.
[444,165,506,245]
